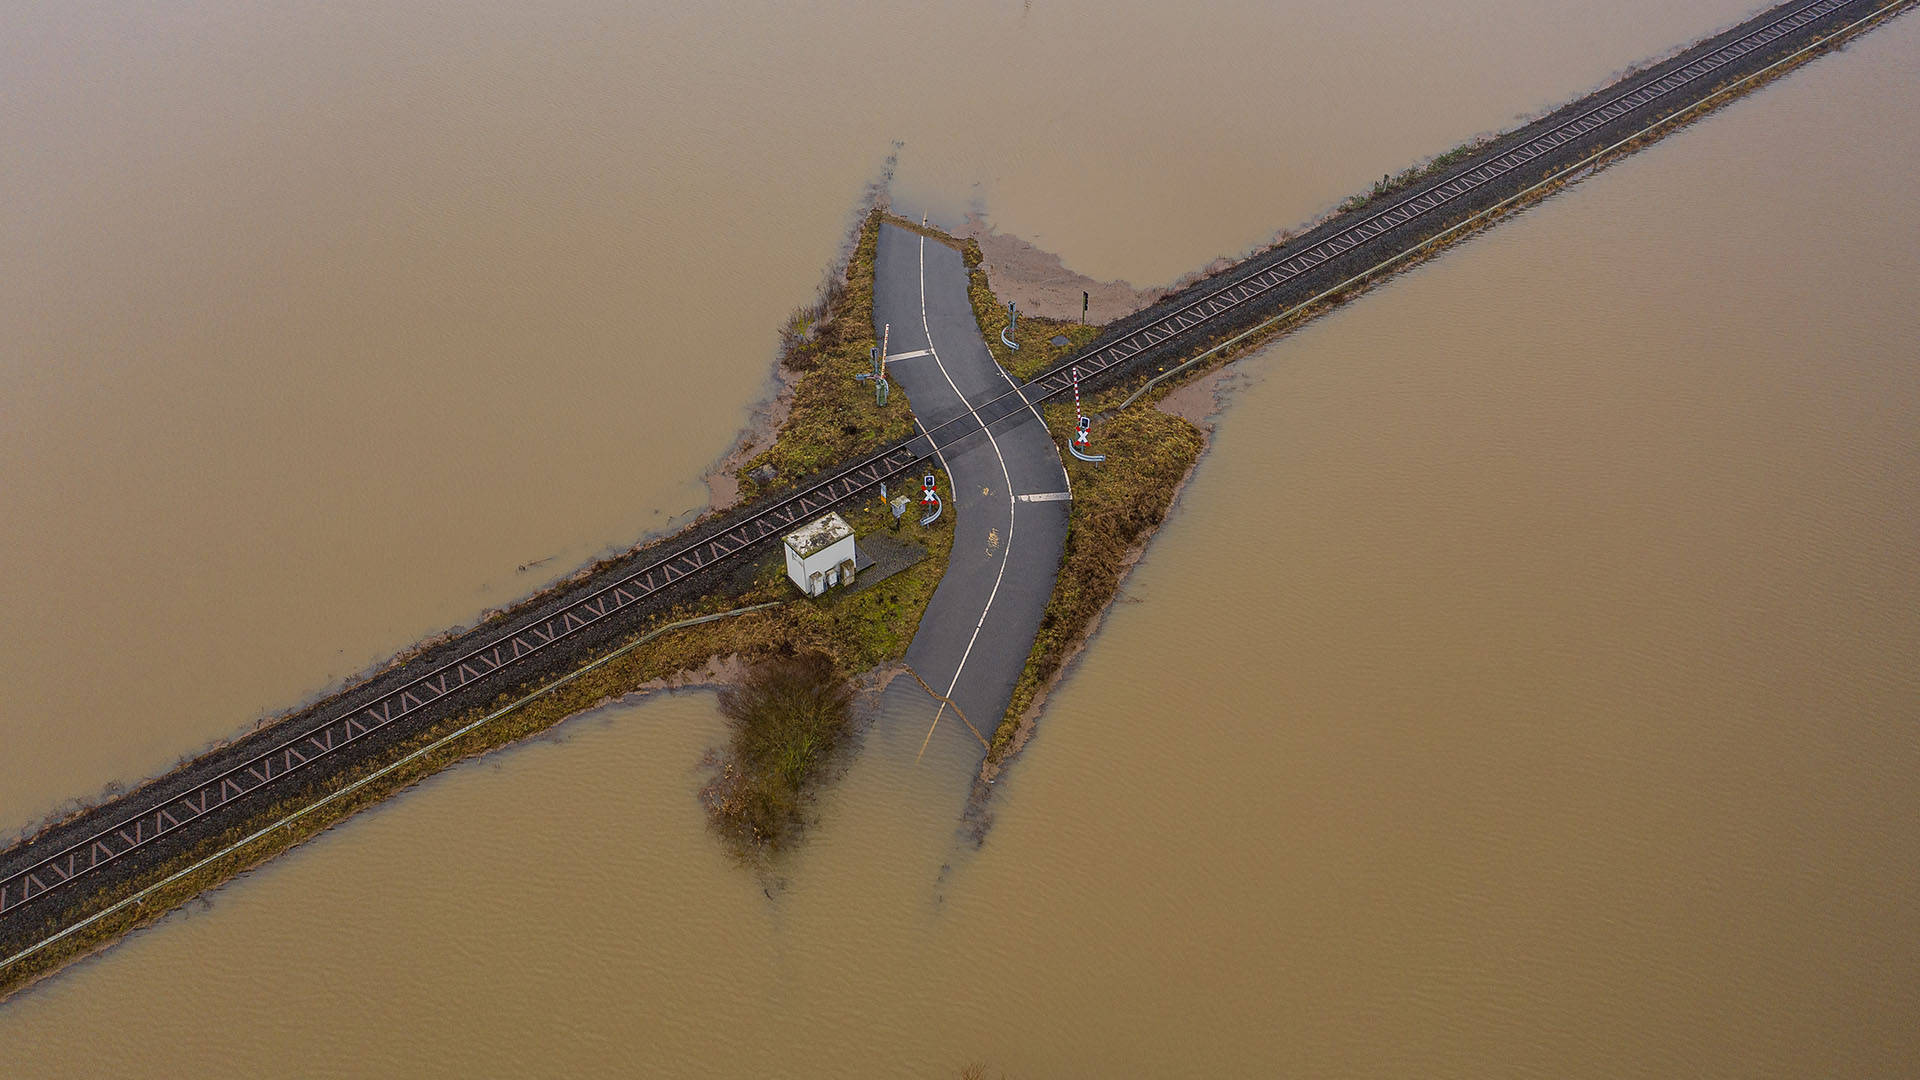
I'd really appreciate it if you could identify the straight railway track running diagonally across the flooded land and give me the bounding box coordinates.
[0,0,1889,915]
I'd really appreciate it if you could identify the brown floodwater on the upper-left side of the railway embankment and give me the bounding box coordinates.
[0,0,1751,836]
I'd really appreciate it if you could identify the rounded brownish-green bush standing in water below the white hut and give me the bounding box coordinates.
[705,651,852,851]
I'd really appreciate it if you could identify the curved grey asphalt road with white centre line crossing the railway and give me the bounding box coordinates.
[874,225,1069,753]
